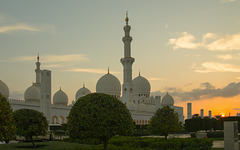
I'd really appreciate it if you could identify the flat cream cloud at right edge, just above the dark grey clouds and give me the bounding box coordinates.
[192,62,240,73]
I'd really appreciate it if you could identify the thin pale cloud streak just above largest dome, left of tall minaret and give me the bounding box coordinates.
[64,68,121,74]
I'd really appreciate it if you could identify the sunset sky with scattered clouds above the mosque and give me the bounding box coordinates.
[0,0,240,118]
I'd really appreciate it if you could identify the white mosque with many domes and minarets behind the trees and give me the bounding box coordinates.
[0,16,184,125]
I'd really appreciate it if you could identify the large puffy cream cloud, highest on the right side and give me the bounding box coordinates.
[168,32,240,51]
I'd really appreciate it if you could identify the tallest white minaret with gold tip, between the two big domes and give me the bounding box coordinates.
[121,13,135,103]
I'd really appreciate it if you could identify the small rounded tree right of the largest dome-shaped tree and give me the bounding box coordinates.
[148,106,182,140]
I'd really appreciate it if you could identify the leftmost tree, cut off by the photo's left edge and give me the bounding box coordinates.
[0,94,16,143]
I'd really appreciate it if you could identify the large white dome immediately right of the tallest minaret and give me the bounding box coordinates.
[133,75,151,97]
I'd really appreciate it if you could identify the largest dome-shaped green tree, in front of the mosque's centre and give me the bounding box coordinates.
[68,93,133,150]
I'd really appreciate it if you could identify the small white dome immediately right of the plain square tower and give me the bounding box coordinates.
[53,89,68,105]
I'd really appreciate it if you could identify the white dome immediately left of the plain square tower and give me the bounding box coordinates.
[24,85,41,102]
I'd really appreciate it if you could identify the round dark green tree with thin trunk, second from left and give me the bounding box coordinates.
[13,109,48,147]
